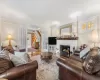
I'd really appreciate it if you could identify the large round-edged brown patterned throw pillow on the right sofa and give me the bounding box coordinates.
[83,49,100,74]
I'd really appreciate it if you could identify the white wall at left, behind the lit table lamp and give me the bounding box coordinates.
[1,18,27,49]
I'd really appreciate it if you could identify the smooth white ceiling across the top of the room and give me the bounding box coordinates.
[0,0,100,26]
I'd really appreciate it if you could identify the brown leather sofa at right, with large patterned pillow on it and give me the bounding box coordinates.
[57,57,100,80]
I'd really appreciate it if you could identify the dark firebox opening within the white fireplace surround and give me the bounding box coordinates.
[60,45,70,57]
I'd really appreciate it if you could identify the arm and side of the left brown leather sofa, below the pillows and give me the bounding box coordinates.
[0,58,38,80]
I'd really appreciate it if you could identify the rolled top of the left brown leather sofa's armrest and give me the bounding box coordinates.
[0,61,38,79]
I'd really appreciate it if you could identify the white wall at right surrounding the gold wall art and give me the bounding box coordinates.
[78,16,98,47]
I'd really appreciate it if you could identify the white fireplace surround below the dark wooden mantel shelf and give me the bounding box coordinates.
[56,40,77,57]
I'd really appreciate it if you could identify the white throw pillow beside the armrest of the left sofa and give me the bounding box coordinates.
[9,54,27,66]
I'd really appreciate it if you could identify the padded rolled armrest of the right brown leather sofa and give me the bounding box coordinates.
[57,58,82,77]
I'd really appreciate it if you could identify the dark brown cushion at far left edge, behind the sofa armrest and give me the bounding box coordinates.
[0,58,13,74]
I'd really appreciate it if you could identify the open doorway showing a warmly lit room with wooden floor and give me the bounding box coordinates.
[27,30,41,56]
